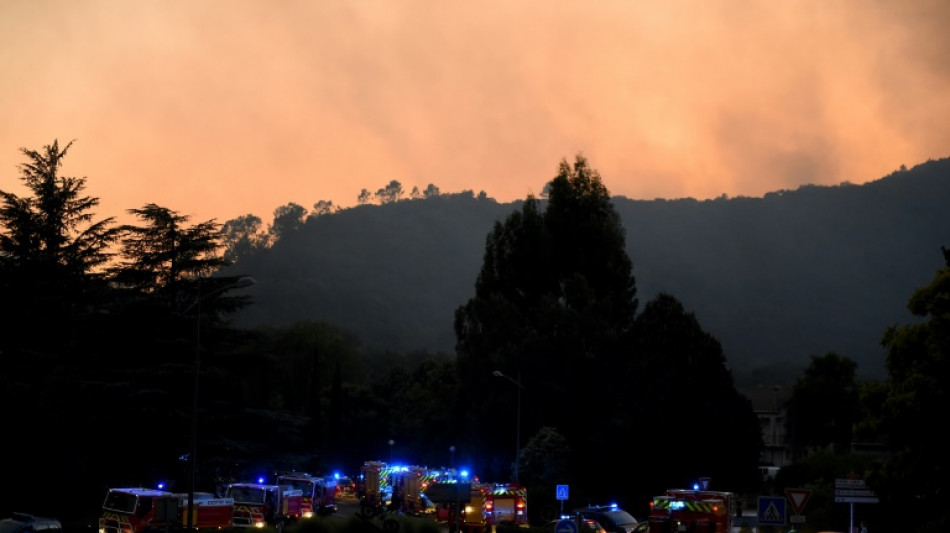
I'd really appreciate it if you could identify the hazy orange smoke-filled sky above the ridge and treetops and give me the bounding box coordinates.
[0,0,950,223]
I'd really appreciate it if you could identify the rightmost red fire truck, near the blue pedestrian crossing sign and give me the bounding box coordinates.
[648,489,737,533]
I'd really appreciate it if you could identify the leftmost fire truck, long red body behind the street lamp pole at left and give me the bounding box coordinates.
[99,487,234,533]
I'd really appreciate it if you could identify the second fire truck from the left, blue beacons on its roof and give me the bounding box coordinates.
[226,483,303,527]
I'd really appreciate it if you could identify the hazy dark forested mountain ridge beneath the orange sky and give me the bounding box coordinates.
[228,159,950,384]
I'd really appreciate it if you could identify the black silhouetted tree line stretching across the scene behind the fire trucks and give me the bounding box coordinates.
[0,142,950,531]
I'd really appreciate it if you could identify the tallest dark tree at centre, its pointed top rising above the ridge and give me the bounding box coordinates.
[455,156,637,486]
